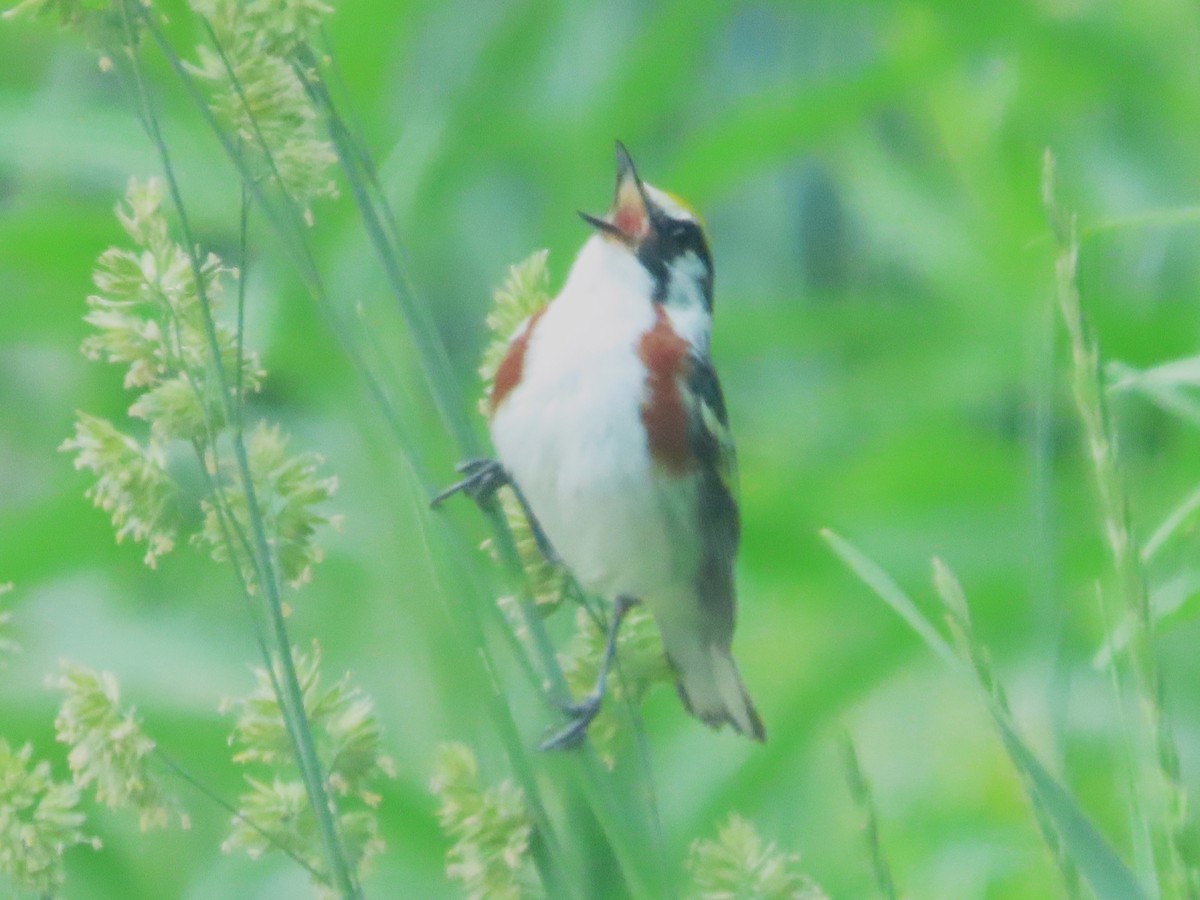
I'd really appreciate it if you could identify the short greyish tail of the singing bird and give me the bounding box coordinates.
[659,619,767,742]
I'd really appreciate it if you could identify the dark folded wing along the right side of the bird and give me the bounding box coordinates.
[685,354,740,648]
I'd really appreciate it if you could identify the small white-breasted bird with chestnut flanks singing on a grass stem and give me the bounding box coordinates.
[434,140,766,750]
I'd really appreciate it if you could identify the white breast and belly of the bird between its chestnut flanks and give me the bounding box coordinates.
[492,236,697,599]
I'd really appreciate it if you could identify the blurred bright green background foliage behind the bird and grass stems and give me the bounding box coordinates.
[0,0,1200,900]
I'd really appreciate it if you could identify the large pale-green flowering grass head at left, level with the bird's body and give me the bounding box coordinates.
[61,179,337,600]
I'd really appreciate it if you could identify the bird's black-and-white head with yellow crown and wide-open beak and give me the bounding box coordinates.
[580,140,713,310]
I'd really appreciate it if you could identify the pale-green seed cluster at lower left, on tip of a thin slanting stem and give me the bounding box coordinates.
[47,662,175,832]
